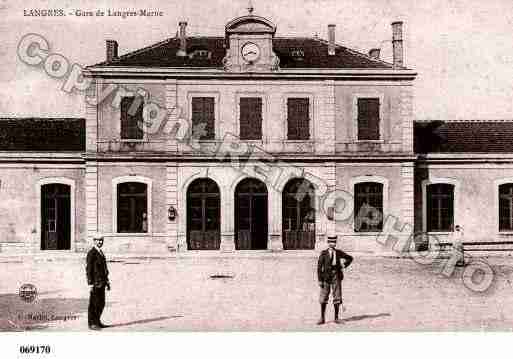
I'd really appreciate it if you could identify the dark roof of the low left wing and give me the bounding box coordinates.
[0,118,85,152]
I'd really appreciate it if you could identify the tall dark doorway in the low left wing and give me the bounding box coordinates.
[41,183,71,250]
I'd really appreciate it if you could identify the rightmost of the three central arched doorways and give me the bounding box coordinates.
[282,178,315,249]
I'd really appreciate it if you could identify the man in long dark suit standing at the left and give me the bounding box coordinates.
[86,234,110,330]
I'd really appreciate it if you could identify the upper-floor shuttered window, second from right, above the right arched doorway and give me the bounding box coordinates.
[287,98,310,141]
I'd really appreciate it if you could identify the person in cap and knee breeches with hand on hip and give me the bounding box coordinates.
[317,235,353,325]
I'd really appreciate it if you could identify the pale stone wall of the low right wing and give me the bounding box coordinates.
[414,158,513,248]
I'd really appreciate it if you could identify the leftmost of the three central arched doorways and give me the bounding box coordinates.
[187,178,221,250]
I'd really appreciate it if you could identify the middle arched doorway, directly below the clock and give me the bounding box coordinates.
[235,178,267,249]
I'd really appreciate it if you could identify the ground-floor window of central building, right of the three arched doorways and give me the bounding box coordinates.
[354,182,383,232]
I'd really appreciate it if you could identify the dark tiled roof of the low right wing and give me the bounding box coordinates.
[414,120,513,153]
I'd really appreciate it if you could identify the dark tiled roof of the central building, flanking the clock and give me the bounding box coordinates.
[91,37,394,69]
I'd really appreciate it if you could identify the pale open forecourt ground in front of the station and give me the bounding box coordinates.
[0,256,513,331]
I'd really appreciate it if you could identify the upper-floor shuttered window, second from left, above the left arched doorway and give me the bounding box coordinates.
[191,97,215,140]
